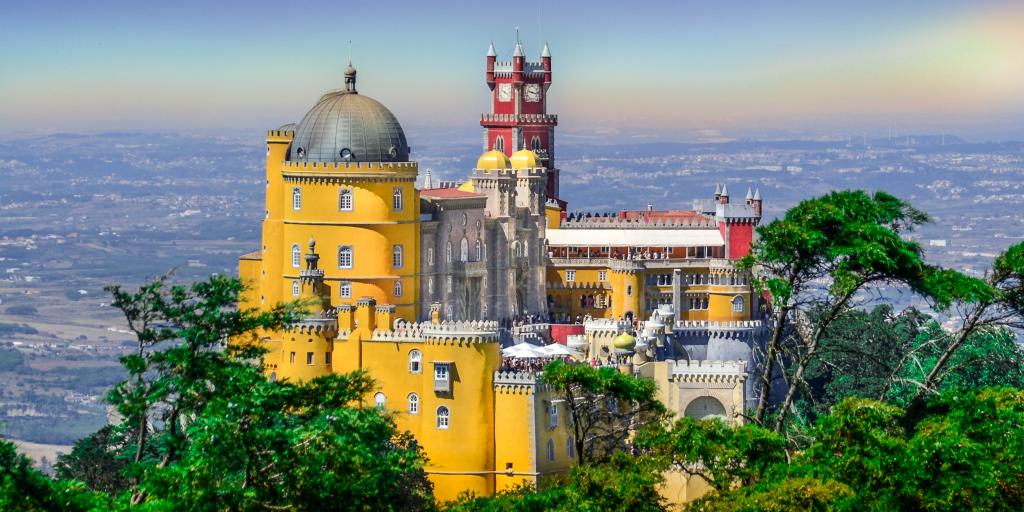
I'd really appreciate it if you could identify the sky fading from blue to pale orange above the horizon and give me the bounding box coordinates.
[0,0,1024,140]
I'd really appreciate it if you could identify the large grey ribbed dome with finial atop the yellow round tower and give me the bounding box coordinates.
[288,62,409,162]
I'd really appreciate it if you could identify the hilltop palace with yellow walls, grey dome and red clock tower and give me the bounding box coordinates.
[239,37,764,500]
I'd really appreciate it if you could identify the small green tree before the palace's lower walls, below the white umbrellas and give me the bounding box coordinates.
[543,360,666,466]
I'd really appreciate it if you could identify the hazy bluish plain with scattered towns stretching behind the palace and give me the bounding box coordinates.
[0,130,1024,456]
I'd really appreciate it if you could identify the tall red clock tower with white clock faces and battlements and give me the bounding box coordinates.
[480,41,558,199]
